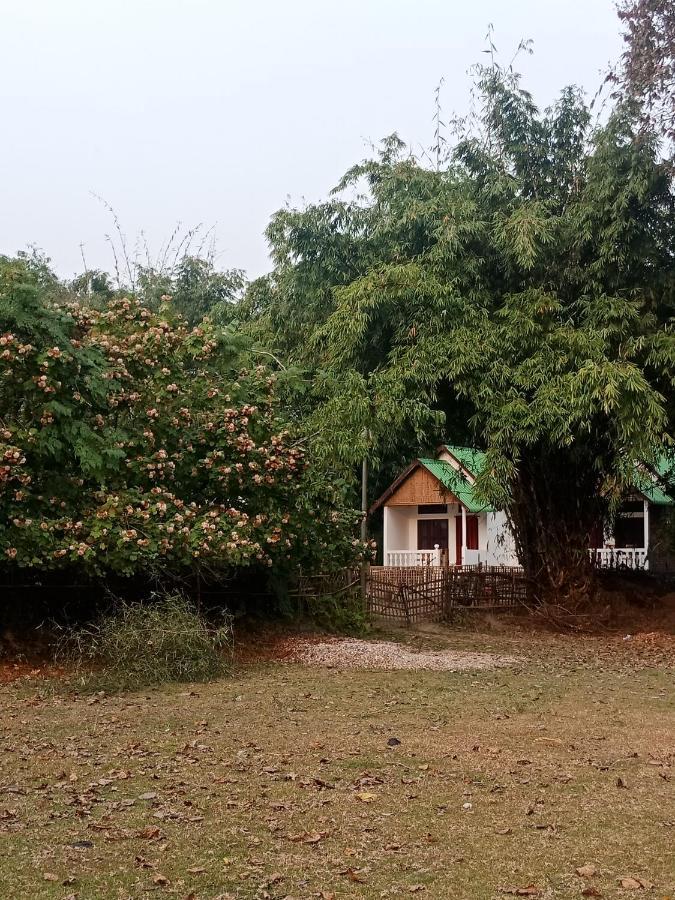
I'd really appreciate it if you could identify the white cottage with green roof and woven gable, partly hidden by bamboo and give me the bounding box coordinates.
[370,445,673,568]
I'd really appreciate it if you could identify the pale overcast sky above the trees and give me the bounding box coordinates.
[0,0,621,276]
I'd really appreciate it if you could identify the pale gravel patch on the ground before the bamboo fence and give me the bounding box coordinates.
[290,638,519,672]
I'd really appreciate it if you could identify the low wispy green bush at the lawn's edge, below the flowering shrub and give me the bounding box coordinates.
[57,594,232,690]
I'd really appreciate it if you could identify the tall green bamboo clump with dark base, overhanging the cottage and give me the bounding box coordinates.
[256,63,675,597]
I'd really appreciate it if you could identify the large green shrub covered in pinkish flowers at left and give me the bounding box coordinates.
[0,264,370,575]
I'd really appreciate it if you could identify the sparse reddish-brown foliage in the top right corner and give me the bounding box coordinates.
[611,0,675,141]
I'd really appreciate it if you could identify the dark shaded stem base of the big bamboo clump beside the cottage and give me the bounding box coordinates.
[507,446,607,613]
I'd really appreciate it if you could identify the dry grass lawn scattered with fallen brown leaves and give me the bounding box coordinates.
[0,631,675,900]
